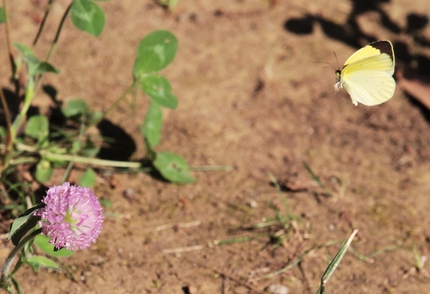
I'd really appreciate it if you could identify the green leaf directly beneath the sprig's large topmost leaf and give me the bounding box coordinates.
[140,75,178,109]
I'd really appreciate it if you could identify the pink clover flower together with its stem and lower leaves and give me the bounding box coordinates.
[0,183,104,293]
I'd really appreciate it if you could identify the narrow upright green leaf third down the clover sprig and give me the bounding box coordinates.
[140,101,163,149]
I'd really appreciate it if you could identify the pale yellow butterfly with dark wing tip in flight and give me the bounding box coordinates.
[334,41,396,106]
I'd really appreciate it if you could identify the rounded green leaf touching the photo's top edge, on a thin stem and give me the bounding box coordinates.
[71,0,105,37]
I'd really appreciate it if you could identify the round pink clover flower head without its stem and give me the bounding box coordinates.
[34,182,103,250]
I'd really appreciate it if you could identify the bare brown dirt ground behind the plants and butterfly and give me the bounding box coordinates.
[0,0,430,294]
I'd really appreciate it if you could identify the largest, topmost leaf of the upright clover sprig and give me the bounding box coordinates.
[133,30,178,79]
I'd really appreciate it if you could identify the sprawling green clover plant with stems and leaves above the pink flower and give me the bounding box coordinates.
[0,0,195,212]
